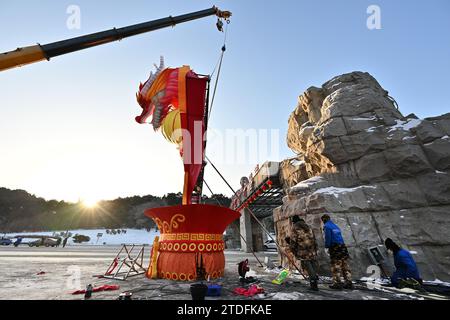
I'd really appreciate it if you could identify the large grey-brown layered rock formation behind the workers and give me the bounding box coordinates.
[274,72,450,281]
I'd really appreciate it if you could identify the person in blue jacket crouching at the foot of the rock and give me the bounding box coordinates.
[384,238,422,287]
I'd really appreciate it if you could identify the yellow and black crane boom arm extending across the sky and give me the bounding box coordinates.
[0,7,231,71]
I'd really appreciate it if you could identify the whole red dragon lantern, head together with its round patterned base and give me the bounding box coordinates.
[136,57,240,281]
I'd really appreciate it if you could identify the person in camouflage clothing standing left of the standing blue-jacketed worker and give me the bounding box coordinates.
[285,216,319,291]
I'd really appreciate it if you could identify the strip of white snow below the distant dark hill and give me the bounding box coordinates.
[6,229,159,245]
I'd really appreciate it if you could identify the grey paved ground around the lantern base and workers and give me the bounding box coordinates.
[0,246,438,300]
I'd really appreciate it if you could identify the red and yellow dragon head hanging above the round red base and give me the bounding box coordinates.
[135,57,209,204]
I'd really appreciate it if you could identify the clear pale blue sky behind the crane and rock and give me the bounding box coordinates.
[0,0,450,201]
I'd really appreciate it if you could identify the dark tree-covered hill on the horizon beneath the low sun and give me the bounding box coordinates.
[0,188,230,233]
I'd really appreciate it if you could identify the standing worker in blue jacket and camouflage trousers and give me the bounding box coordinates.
[321,214,353,290]
